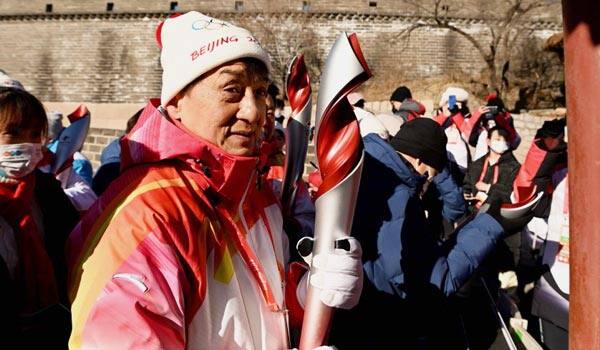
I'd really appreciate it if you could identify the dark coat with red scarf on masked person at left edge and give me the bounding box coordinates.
[0,170,79,349]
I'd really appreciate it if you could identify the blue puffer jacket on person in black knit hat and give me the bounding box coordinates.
[352,134,502,297]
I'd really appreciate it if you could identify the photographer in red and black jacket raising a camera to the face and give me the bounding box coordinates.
[467,93,521,160]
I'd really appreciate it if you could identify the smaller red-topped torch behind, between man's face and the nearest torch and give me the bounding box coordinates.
[281,55,312,215]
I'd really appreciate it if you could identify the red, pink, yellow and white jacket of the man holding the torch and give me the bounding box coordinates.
[68,100,295,349]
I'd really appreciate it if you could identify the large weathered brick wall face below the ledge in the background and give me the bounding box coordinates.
[0,10,562,103]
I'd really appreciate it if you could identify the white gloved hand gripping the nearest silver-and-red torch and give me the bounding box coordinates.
[296,237,363,309]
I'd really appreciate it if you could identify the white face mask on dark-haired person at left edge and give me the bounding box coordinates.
[0,143,43,179]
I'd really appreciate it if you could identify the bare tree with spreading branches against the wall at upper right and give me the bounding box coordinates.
[398,0,560,91]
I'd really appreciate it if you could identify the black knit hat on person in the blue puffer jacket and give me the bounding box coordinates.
[390,118,448,172]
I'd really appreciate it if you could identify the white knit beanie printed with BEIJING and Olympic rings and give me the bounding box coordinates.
[157,11,271,106]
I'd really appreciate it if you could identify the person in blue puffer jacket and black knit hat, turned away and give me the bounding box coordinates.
[330,118,528,349]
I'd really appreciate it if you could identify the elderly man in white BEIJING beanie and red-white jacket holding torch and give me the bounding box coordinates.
[69,12,362,349]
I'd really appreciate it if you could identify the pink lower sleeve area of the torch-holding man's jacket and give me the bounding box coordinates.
[77,233,187,349]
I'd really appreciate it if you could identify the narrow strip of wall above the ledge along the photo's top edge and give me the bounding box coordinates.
[0,0,561,21]
